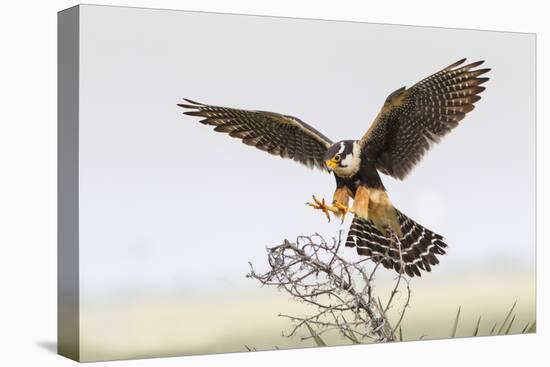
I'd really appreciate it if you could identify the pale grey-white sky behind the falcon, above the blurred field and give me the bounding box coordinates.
[80,6,535,302]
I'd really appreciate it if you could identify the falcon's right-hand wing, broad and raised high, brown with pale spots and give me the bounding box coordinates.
[361,59,491,179]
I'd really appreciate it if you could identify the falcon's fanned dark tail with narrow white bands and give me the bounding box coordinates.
[346,209,447,277]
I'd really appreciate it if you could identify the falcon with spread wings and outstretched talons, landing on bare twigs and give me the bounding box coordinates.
[178,59,490,277]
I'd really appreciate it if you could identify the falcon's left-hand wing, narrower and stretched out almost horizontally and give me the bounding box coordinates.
[178,99,332,170]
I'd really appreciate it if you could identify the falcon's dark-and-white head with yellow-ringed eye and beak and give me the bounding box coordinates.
[323,140,361,177]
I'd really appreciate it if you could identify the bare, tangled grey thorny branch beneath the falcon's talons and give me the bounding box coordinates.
[247,233,411,343]
